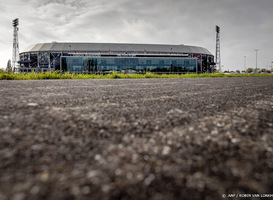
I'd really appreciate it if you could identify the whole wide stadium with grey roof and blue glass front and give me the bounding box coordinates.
[19,42,215,73]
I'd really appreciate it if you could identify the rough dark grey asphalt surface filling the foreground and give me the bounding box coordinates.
[0,77,273,200]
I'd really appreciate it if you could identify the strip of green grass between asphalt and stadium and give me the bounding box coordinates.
[0,71,273,80]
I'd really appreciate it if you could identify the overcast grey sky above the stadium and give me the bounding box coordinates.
[0,0,273,70]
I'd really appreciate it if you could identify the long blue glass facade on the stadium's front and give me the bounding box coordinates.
[60,56,197,73]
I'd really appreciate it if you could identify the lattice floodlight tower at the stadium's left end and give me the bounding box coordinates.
[12,18,19,71]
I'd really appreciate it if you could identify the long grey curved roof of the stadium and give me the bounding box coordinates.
[22,42,212,55]
